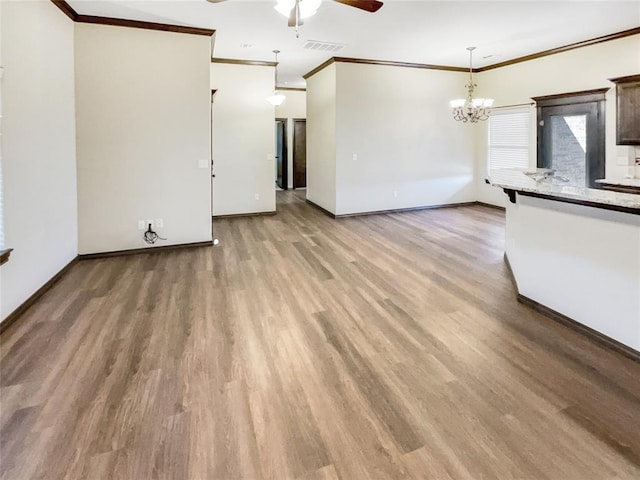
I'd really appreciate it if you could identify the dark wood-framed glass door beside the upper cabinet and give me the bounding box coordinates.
[534,88,608,188]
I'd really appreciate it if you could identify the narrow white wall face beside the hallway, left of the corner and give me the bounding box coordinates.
[306,63,337,213]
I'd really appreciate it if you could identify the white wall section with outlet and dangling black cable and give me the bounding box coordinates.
[75,24,211,254]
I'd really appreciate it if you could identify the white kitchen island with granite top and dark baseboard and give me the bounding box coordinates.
[490,170,640,360]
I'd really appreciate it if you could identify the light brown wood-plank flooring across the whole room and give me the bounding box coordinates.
[0,191,640,480]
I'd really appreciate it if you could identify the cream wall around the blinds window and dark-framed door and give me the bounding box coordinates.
[476,35,640,205]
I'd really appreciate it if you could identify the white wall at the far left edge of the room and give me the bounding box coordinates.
[0,1,78,319]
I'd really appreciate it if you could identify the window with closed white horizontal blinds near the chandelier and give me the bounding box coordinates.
[487,109,529,173]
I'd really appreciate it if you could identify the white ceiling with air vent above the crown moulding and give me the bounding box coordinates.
[68,0,640,87]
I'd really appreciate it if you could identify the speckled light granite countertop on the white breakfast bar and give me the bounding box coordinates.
[489,170,640,213]
